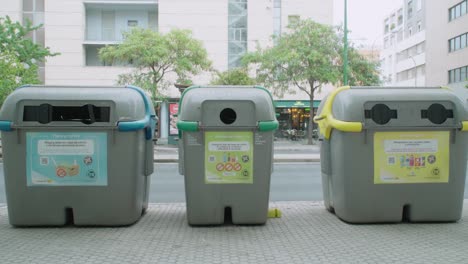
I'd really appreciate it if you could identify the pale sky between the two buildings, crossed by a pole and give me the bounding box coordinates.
[333,0,403,47]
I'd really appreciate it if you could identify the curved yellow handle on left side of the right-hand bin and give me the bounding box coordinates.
[314,86,362,139]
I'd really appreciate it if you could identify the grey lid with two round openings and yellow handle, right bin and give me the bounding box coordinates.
[314,86,468,138]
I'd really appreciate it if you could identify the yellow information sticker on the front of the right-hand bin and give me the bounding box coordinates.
[374,131,450,184]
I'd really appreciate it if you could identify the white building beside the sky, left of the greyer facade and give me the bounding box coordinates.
[380,0,426,86]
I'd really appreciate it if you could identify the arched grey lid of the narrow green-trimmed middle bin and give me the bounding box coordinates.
[178,86,276,122]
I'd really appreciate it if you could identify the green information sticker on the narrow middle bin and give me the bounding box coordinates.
[205,131,253,184]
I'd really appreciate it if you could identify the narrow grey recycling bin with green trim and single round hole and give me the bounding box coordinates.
[177,86,278,225]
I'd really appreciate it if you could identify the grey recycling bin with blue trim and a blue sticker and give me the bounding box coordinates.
[0,86,156,226]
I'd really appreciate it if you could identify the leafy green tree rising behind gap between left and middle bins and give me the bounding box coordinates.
[99,28,211,98]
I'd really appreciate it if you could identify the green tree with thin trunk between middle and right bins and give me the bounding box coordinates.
[243,20,340,144]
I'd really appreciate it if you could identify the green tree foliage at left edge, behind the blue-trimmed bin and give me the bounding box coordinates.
[0,16,58,104]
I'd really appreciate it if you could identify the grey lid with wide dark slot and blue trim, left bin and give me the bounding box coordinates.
[0,85,155,131]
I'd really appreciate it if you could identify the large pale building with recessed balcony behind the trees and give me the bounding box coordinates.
[0,0,333,143]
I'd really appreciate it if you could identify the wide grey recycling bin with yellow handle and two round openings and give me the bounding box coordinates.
[315,87,468,223]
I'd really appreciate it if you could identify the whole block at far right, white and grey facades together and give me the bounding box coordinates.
[381,0,468,88]
